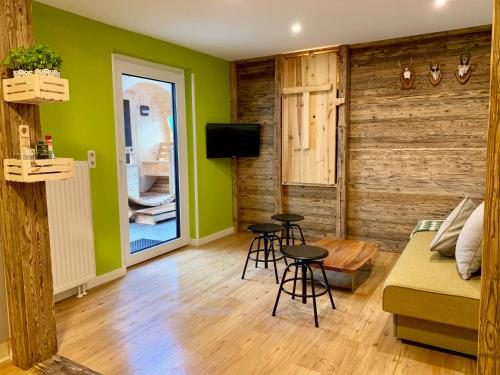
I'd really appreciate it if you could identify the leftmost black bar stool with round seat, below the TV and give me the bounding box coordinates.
[241,224,288,284]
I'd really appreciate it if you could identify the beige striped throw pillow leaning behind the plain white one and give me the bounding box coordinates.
[431,197,475,257]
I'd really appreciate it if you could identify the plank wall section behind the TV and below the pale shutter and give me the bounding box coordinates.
[232,57,336,239]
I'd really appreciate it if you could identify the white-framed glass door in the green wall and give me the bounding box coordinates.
[112,54,189,266]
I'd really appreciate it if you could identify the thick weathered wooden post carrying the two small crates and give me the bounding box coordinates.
[0,0,57,369]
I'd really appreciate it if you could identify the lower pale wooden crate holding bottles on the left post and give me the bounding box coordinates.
[3,158,73,183]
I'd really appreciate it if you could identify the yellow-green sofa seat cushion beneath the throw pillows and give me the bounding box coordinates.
[382,232,481,329]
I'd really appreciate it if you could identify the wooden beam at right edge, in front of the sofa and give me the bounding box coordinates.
[477,0,500,374]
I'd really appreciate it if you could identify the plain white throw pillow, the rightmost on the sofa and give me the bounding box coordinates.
[455,202,484,280]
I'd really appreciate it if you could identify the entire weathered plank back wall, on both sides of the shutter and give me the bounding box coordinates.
[235,28,491,251]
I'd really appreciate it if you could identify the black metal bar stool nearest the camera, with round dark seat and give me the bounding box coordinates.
[273,245,335,327]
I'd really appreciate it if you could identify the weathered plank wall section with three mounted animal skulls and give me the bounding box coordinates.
[347,31,491,251]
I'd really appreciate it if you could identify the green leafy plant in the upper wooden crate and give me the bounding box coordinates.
[3,44,62,70]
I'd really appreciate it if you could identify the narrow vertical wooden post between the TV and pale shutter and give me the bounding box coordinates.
[274,55,283,213]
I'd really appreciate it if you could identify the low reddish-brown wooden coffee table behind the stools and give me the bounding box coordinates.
[311,237,378,291]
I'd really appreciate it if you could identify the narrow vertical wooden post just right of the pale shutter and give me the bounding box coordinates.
[335,45,351,239]
